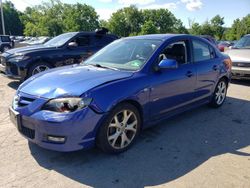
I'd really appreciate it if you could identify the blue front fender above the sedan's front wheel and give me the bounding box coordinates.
[86,73,149,121]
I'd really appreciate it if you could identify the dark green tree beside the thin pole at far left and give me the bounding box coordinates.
[0,1,23,35]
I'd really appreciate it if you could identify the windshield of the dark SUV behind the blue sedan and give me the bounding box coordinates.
[44,33,76,47]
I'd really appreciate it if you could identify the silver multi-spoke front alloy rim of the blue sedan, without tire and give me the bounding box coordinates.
[107,110,138,149]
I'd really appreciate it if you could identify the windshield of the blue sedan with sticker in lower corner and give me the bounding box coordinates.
[84,39,162,71]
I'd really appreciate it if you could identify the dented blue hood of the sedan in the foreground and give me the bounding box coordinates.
[18,65,133,99]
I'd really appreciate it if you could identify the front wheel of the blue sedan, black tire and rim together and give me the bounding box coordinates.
[97,103,141,154]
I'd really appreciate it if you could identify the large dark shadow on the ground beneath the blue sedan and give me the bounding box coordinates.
[29,98,250,187]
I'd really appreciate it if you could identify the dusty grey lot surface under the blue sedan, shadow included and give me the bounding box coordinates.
[0,75,250,188]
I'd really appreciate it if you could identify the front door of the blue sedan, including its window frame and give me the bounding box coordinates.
[150,39,196,119]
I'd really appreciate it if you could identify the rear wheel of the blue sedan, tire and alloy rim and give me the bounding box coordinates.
[209,78,228,108]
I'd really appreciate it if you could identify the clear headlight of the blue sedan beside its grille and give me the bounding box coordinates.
[42,97,92,113]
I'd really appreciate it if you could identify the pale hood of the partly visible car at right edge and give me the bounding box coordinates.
[225,49,250,62]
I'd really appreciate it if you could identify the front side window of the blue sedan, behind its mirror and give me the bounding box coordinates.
[159,41,188,65]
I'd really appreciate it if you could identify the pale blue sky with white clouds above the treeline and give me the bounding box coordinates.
[9,0,250,27]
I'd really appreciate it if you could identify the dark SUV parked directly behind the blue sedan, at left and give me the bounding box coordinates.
[0,30,118,81]
